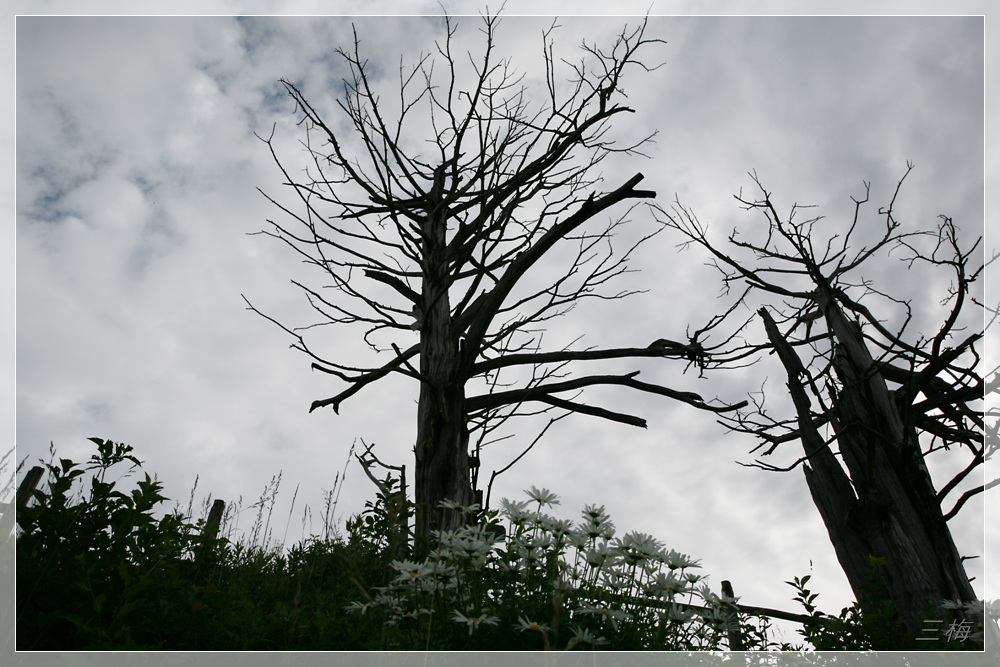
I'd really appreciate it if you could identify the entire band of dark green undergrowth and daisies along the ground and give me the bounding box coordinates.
[23,438,954,651]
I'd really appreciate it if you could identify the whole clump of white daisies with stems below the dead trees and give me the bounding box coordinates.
[345,487,727,650]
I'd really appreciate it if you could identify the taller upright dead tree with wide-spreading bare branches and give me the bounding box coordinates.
[248,16,735,536]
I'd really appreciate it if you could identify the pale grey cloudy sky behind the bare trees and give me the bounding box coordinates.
[4,3,1000,640]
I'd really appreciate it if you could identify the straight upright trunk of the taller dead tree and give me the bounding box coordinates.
[414,175,473,538]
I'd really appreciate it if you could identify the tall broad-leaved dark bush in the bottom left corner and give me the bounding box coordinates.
[16,438,209,650]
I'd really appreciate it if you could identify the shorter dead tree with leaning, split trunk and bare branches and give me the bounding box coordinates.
[665,165,997,638]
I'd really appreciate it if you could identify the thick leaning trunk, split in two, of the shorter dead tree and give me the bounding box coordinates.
[761,290,975,639]
